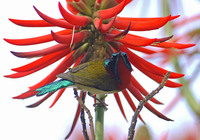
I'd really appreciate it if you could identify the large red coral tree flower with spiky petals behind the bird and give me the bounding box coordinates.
[4,0,194,137]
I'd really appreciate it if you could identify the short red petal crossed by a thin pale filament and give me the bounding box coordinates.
[51,31,90,44]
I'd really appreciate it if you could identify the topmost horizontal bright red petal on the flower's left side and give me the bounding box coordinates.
[9,18,53,27]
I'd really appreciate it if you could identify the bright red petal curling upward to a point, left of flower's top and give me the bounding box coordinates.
[58,2,92,26]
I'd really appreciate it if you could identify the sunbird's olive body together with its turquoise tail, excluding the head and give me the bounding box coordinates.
[36,59,118,96]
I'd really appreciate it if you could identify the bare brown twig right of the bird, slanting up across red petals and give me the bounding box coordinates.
[127,71,171,140]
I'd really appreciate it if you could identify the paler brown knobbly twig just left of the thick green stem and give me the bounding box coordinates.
[74,89,95,140]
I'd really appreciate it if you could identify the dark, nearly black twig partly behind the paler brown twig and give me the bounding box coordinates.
[79,89,89,140]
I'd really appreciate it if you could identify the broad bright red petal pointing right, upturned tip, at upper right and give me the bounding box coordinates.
[114,15,171,31]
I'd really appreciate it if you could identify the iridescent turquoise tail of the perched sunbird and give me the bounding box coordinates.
[35,79,74,96]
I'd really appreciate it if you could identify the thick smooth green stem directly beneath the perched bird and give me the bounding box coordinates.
[95,94,105,140]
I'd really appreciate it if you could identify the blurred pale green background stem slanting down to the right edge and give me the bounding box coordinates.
[172,56,200,116]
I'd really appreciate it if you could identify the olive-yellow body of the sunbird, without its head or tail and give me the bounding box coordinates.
[57,59,118,93]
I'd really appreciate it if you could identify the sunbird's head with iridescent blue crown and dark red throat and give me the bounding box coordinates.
[104,52,132,84]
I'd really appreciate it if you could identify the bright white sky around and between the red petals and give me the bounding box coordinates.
[0,0,200,140]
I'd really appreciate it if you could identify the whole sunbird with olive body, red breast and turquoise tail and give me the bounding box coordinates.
[35,52,132,96]
